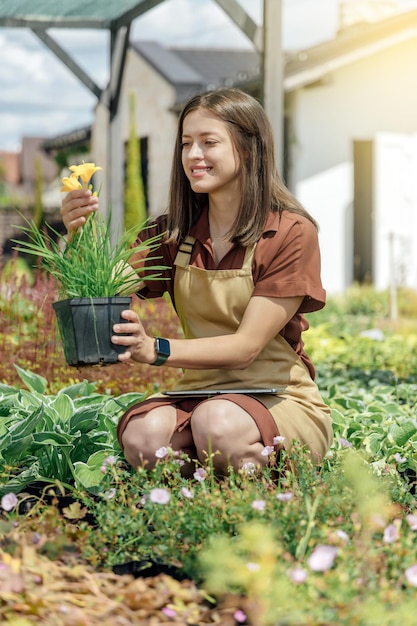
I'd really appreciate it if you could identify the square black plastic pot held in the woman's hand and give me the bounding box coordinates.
[53,296,132,365]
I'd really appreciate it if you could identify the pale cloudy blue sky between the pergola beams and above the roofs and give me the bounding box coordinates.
[0,0,417,151]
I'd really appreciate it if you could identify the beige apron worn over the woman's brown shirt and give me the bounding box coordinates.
[169,236,332,459]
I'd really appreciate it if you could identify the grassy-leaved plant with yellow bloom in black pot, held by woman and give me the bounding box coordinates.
[14,163,164,366]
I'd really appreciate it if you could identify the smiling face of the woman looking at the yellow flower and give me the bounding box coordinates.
[182,109,240,194]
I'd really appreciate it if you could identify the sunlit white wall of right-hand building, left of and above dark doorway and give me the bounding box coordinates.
[291,40,417,293]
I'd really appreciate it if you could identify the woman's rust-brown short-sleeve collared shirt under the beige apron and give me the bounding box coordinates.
[132,209,326,377]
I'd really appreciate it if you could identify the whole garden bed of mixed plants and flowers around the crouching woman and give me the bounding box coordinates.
[0,266,417,626]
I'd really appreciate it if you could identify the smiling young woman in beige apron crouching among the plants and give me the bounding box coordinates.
[61,89,332,472]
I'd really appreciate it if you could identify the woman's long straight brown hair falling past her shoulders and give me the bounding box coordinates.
[168,89,317,246]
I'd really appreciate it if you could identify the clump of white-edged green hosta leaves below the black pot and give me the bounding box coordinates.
[0,366,143,495]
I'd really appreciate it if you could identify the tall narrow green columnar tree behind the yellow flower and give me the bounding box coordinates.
[124,93,146,238]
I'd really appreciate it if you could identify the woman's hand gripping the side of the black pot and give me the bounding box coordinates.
[111,309,156,364]
